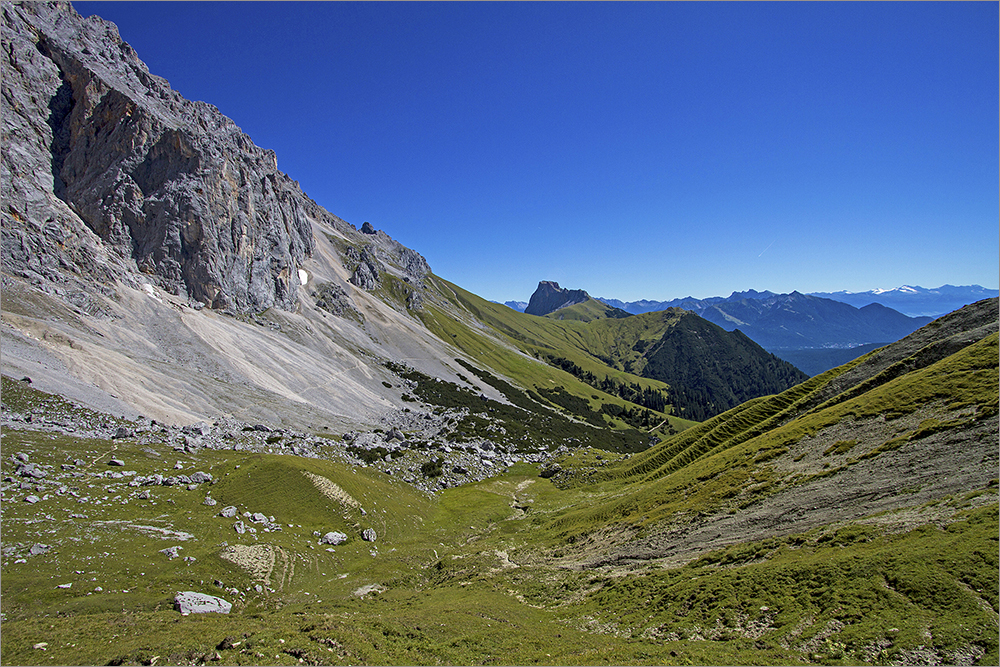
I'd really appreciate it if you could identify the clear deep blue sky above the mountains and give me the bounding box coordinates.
[74,2,1000,301]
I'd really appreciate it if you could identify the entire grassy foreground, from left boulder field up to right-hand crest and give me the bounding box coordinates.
[2,300,1000,665]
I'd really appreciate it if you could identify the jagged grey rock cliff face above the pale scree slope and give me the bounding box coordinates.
[2,3,378,312]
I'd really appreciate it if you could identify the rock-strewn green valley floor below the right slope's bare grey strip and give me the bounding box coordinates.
[0,376,998,665]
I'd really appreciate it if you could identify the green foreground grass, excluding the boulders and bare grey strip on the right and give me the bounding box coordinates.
[2,342,998,665]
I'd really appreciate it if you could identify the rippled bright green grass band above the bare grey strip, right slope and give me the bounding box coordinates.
[557,334,1000,532]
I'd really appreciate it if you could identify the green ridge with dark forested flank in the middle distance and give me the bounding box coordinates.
[424,278,806,421]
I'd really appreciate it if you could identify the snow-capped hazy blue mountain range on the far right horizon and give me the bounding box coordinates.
[812,285,1000,317]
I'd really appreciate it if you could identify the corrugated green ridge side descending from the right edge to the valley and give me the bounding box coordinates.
[559,307,1000,530]
